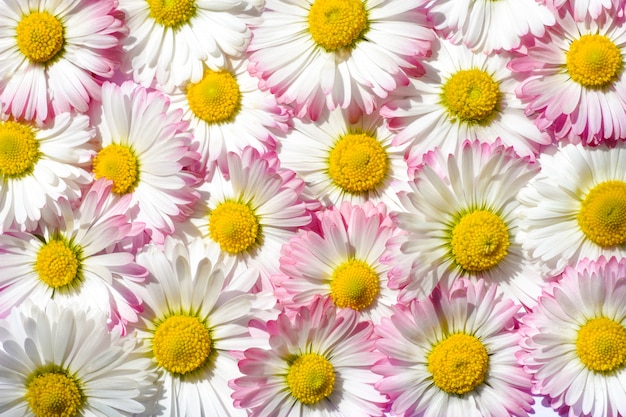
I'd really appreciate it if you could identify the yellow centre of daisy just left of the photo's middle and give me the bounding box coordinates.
[209,201,261,255]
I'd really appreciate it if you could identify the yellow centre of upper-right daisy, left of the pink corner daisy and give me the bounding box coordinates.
[441,69,502,124]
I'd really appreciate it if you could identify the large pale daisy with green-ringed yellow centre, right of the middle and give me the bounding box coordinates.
[393,141,542,305]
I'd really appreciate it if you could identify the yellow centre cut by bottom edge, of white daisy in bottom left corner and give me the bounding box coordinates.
[26,372,84,417]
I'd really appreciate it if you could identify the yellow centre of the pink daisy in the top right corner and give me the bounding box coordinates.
[566,34,623,88]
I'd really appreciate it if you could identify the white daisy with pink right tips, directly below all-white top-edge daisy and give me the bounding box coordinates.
[169,60,290,161]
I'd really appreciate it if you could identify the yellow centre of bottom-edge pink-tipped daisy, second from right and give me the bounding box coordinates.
[428,333,489,395]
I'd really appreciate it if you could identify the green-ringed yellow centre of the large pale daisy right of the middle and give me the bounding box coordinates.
[450,210,509,272]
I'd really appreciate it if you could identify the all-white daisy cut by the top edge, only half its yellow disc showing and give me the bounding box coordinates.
[120,0,263,91]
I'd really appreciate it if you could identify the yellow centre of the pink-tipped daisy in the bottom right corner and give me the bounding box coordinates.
[576,317,626,372]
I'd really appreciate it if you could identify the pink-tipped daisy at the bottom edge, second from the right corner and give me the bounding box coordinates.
[373,279,533,417]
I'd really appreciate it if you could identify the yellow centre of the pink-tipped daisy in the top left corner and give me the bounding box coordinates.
[15,12,65,64]
